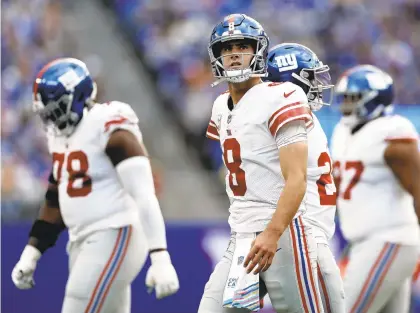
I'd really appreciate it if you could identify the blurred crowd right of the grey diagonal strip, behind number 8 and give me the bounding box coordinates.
[107,0,420,168]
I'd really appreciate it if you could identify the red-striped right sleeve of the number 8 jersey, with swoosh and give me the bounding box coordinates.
[268,83,313,138]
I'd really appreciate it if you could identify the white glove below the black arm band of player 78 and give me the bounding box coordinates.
[12,245,41,289]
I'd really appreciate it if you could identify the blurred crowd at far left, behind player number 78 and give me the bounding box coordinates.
[1,0,108,220]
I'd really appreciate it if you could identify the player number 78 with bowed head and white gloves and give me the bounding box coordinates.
[12,58,179,313]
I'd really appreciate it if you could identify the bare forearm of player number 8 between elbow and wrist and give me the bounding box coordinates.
[267,173,306,233]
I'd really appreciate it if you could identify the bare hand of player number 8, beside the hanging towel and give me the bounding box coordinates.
[244,228,281,274]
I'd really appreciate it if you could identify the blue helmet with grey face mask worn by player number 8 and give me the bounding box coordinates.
[208,14,269,86]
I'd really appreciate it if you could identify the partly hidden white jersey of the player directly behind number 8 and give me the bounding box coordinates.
[305,114,337,243]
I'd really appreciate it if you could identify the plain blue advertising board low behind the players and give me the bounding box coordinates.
[1,222,420,313]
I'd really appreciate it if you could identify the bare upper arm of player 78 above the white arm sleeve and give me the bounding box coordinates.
[105,129,147,166]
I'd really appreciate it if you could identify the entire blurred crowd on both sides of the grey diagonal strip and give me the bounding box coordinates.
[1,0,420,219]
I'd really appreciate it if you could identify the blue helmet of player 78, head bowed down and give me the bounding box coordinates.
[32,58,96,136]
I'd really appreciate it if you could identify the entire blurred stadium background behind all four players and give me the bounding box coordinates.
[1,0,420,313]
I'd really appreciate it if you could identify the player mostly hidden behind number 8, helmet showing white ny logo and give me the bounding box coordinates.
[267,43,345,313]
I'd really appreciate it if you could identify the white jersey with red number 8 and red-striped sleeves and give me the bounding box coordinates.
[206,82,313,232]
